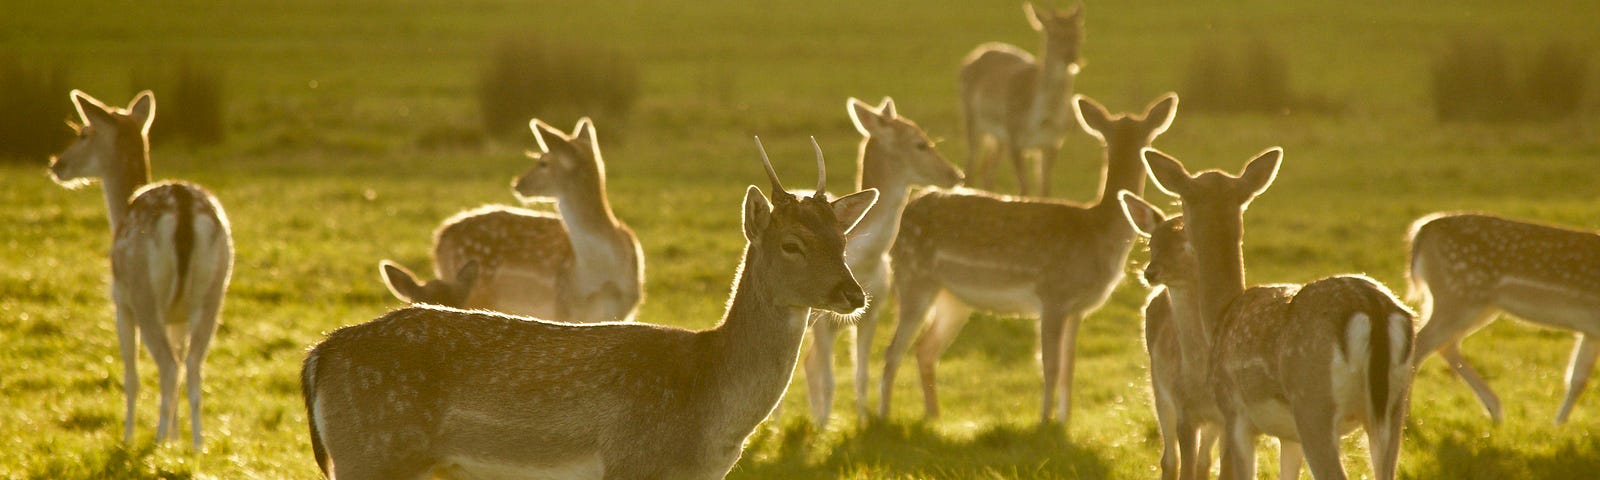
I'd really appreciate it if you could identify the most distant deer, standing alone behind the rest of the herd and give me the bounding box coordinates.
[960,3,1083,197]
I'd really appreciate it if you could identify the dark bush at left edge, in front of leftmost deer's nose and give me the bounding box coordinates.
[0,54,77,162]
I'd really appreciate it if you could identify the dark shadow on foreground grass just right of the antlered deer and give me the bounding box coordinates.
[730,419,1110,478]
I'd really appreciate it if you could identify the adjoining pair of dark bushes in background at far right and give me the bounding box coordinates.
[1432,32,1589,122]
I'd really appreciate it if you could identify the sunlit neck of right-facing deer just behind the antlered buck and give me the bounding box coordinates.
[850,141,910,258]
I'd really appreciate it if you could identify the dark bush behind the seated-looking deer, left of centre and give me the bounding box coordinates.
[478,37,638,134]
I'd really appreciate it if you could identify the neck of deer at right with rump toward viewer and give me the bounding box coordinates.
[1184,206,1245,326]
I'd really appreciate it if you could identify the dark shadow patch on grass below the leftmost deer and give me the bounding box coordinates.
[27,442,194,480]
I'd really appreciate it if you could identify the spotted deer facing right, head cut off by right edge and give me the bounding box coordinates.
[1406,213,1600,424]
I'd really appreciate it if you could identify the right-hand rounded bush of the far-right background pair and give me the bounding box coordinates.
[1522,42,1589,118]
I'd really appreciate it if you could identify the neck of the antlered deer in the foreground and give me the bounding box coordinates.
[706,248,810,435]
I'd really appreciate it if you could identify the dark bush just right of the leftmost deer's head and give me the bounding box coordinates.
[130,59,227,146]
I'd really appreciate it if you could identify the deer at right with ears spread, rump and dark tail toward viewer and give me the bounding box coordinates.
[1144,147,1416,480]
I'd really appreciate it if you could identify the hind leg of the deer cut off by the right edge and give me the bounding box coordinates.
[1413,298,1501,424]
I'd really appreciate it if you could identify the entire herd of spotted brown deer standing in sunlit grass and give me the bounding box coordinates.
[50,5,1600,480]
